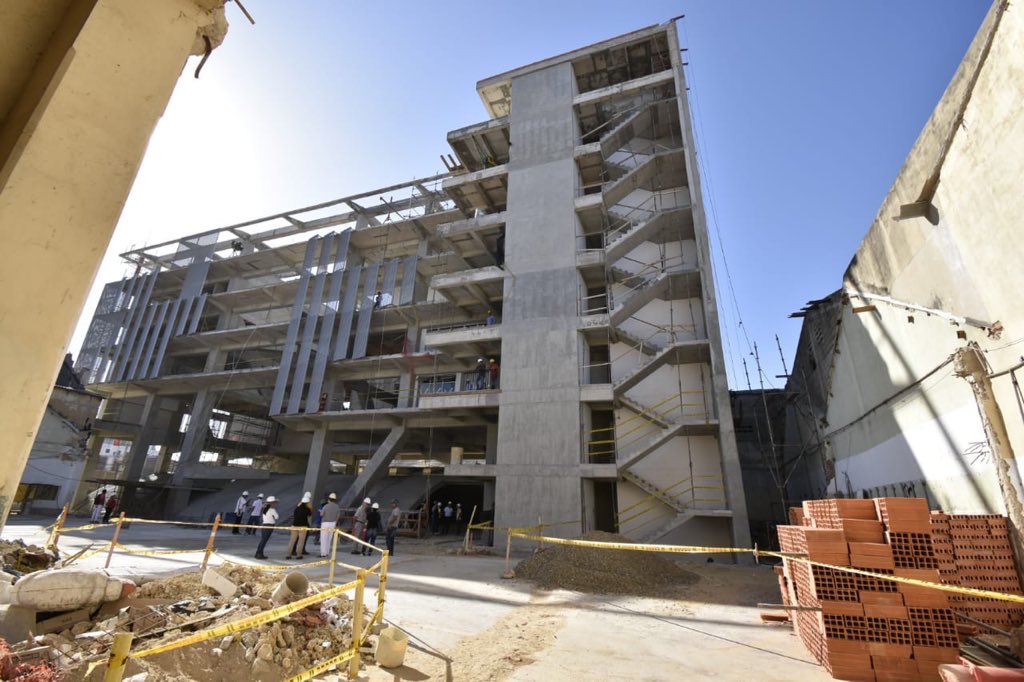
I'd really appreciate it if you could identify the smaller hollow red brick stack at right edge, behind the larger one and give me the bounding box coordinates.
[932,512,1024,630]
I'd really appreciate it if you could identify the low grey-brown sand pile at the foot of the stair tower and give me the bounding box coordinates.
[515,531,700,595]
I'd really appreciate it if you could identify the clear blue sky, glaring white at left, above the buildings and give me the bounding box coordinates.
[71,0,989,388]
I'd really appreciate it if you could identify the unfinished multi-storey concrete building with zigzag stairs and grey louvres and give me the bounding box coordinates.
[70,23,749,546]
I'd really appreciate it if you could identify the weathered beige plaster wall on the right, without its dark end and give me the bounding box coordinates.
[826,0,1024,511]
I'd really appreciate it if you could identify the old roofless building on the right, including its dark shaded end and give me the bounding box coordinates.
[786,2,1024,513]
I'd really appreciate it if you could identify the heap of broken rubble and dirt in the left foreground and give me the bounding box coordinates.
[0,566,370,682]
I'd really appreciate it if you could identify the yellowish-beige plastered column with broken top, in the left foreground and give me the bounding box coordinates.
[0,0,227,526]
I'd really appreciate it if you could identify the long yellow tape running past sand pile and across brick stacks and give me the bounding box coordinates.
[509,531,1024,604]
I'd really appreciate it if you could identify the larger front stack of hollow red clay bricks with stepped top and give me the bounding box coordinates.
[778,498,959,682]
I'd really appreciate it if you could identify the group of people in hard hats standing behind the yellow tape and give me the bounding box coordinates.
[231,491,401,559]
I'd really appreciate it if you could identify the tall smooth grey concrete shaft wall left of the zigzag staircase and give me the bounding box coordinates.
[495,62,581,542]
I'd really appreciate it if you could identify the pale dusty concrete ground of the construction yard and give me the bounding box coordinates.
[3,517,830,682]
